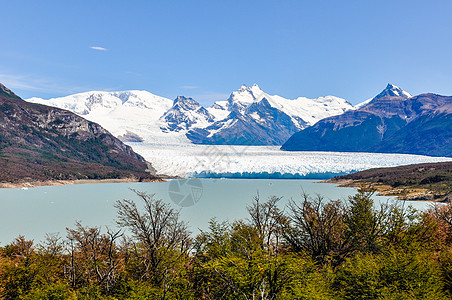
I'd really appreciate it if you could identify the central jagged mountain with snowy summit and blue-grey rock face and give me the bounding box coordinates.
[187,84,353,145]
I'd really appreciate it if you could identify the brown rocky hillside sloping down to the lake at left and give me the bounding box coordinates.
[0,84,153,182]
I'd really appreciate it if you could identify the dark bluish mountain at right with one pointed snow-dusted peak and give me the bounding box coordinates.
[281,84,452,157]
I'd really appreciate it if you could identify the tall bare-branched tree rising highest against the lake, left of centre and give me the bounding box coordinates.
[115,190,191,298]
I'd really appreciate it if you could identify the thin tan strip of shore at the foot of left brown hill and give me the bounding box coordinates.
[0,177,166,188]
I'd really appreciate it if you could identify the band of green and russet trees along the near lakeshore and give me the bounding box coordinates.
[0,188,452,299]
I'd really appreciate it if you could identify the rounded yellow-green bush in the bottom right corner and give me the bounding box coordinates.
[333,249,450,299]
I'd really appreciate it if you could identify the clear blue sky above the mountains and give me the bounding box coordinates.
[0,0,452,105]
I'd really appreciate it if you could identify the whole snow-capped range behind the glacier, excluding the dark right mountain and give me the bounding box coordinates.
[27,84,354,145]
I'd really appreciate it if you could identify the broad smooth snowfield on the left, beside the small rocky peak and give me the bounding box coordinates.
[27,91,190,144]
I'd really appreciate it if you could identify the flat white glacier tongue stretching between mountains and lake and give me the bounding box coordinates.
[128,143,452,177]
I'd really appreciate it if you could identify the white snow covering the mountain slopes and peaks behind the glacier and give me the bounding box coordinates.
[27,84,374,145]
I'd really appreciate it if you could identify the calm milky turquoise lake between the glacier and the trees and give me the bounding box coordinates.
[0,179,427,246]
